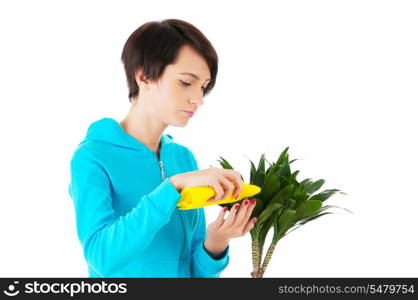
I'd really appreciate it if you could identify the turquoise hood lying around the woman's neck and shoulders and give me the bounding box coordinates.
[80,118,173,155]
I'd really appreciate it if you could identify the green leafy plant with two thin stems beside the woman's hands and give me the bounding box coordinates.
[218,147,352,278]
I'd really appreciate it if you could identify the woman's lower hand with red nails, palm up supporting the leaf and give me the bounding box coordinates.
[204,199,257,255]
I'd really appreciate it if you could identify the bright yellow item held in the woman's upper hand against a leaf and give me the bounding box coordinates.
[177,183,261,210]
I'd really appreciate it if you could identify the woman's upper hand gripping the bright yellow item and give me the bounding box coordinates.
[169,167,243,202]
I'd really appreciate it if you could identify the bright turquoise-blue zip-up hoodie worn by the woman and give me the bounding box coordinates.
[69,118,229,278]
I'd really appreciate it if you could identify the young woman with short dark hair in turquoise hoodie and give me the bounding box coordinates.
[69,19,255,277]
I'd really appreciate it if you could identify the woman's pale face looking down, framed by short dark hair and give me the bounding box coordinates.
[137,45,210,127]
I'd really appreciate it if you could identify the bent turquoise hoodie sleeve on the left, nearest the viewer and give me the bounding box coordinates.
[69,151,181,277]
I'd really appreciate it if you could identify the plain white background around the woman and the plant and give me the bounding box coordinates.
[0,0,418,277]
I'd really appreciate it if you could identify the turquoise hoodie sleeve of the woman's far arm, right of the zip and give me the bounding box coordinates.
[189,150,229,278]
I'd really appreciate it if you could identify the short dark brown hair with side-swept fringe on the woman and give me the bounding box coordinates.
[121,19,218,102]
